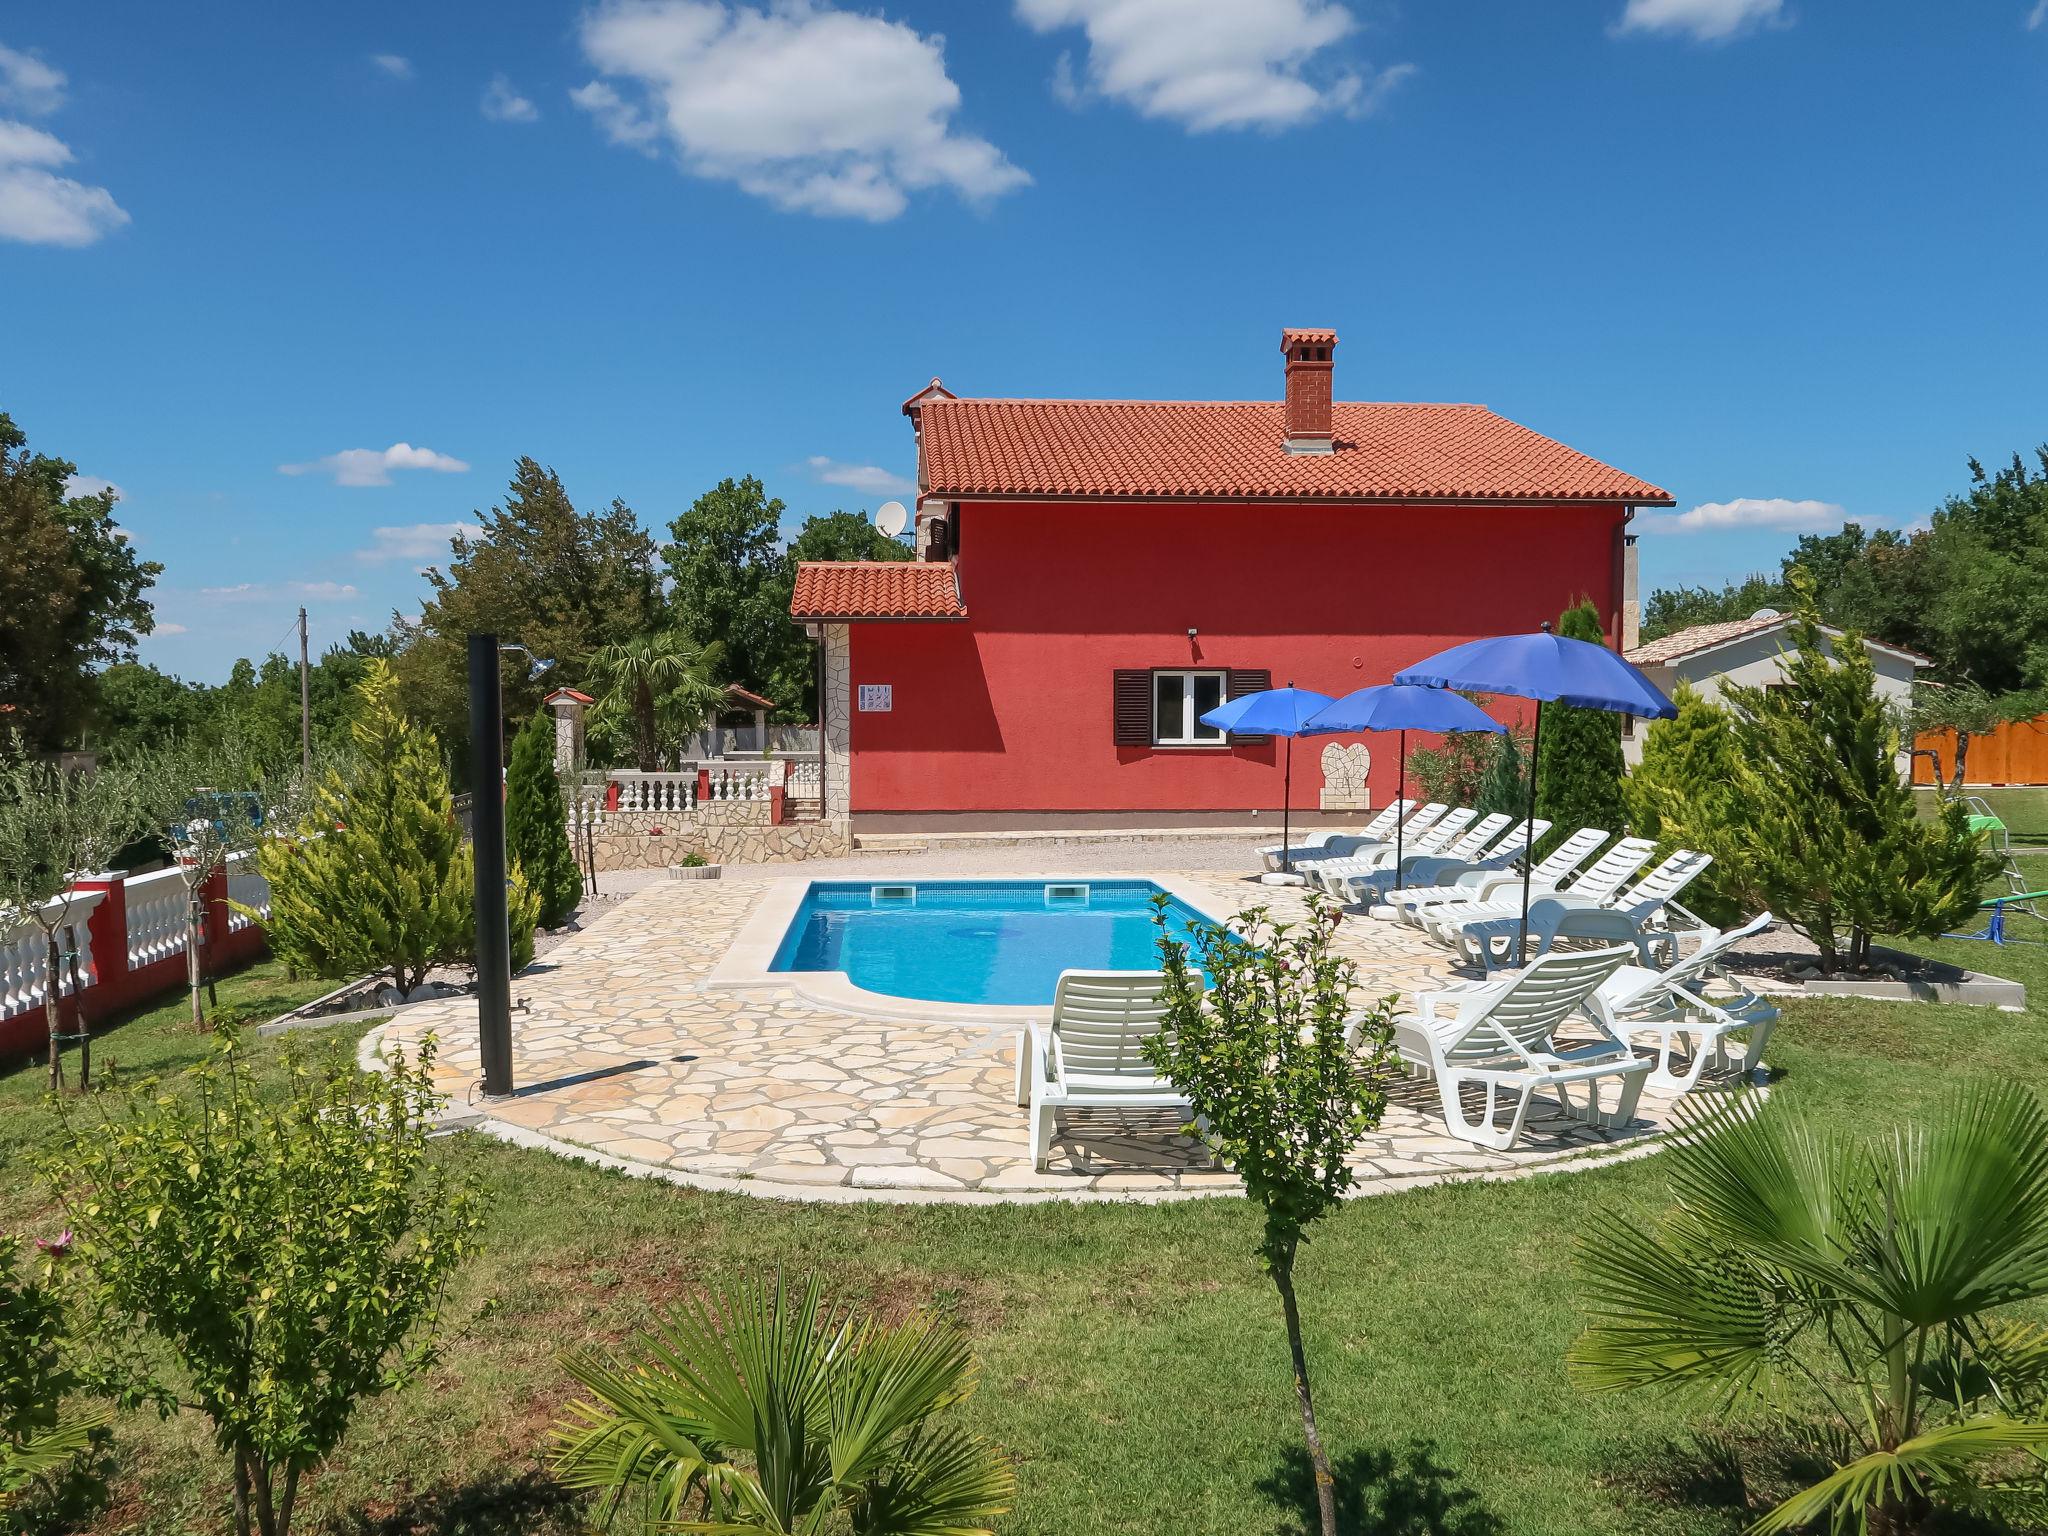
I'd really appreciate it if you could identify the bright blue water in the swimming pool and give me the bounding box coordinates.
[772,881,1200,1006]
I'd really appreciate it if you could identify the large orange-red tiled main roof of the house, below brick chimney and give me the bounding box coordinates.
[918,399,1673,506]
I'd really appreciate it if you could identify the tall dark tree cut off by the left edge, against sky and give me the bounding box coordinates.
[0,412,164,752]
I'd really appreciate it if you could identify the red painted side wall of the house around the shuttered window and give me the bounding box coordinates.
[848,504,1624,813]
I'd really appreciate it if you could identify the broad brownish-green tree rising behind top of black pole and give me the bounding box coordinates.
[393,459,662,760]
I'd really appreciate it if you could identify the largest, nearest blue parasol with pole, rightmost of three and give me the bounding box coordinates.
[1395,625,1677,965]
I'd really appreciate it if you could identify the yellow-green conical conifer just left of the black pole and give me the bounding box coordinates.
[258,659,537,991]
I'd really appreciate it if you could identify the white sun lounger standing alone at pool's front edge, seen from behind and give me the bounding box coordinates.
[1018,971,1194,1169]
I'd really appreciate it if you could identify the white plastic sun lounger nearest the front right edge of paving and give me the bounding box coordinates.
[1354,948,1651,1151]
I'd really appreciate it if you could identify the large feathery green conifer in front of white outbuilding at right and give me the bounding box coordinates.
[1688,573,1997,971]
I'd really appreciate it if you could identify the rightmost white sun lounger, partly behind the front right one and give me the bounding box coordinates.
[1593,911,1778,1094]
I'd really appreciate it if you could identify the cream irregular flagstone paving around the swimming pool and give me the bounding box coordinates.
[365,860,1712,1204]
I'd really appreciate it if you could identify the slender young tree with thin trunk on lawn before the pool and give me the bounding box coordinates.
[1145,895,1393,1536]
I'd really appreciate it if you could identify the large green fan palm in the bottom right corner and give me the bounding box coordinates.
[1569,1083,2048,1536]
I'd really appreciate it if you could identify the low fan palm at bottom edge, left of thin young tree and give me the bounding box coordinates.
[555,1280,1014,1536]
